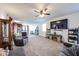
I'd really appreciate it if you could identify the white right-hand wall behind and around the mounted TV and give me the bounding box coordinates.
[39,12,79,42]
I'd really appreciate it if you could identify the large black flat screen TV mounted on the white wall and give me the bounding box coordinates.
[50,19,68,29]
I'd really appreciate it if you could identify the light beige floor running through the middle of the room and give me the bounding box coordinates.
[14,35,63,56]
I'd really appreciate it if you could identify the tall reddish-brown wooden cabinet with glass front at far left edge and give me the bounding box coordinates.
[0,19,12,50]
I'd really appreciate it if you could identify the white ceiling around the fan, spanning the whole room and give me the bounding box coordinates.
[0,3,79,24]
